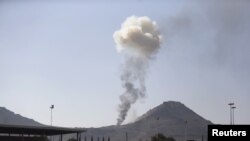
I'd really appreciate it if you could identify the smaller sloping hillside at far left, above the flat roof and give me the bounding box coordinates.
[0,107,42,126]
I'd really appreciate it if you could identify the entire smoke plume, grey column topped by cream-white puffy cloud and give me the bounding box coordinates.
[113,16,161,125]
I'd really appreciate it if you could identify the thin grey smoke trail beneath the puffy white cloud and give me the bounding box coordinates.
[117,58,146,125]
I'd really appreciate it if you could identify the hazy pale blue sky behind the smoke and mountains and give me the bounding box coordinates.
[0,0,250,127]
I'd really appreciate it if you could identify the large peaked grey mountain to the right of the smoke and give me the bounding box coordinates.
[84,101,212,141]
